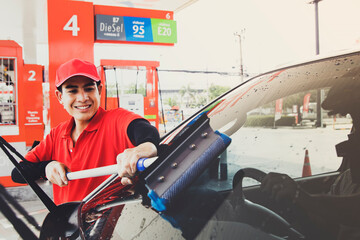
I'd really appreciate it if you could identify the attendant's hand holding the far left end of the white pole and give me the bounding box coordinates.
[45,161,69,187]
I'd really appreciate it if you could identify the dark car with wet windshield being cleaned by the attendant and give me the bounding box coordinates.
[8,51,360,239]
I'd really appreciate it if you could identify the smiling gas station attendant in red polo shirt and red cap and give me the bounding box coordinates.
[12,59,160,204]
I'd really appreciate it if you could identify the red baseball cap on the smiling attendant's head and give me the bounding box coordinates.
[55,58,100,87]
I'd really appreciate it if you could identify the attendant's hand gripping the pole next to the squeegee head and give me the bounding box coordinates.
[116,142,157,185]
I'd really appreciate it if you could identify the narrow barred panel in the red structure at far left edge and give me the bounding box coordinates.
[0,57,17,126]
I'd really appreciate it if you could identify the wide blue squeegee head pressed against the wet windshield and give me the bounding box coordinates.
[144,114,231,212]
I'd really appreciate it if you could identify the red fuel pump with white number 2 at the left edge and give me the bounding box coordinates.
[0,40,44,187]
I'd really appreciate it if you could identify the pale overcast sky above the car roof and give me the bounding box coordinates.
[169,0,360,75]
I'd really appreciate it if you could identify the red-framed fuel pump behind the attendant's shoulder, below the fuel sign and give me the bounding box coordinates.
[100,60,160,129]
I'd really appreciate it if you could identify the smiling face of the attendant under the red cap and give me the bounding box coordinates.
[56,76,102,124]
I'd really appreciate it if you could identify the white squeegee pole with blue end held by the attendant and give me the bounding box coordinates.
[66,157,157,180]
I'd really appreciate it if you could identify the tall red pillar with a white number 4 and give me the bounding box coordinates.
[47,0,94,127]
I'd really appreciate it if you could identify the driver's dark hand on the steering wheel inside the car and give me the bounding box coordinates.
[260,172,300,201]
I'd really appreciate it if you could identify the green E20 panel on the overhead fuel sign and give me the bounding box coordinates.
[151,18,177,43]
